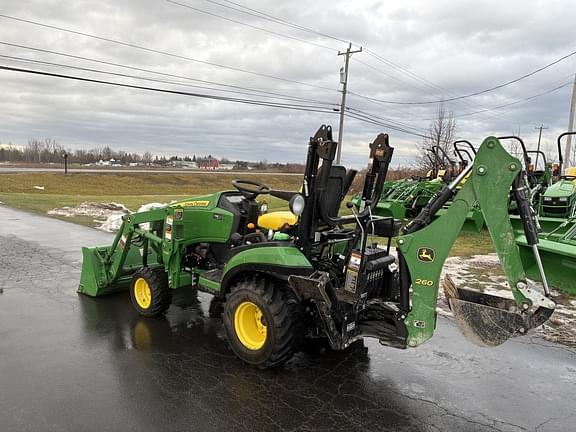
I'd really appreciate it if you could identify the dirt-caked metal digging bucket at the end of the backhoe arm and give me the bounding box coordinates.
[444,276,554,347]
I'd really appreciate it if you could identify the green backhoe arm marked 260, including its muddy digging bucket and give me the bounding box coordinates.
[397,137,555,347]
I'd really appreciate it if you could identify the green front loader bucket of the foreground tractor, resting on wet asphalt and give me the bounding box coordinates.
[78,247,129,297]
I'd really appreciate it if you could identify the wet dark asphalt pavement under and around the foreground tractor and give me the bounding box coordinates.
[0,205,576,432]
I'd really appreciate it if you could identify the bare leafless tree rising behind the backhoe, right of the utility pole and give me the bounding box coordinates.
[418,105,456,171]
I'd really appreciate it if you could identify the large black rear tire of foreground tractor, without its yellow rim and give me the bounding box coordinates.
[223,278,304,369]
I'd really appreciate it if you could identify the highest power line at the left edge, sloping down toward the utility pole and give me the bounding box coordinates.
[0,14,334,92]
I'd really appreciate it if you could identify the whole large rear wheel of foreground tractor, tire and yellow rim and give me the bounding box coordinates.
[223,278,303,369]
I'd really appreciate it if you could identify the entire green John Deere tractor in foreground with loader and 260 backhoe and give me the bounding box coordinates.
[79,126,555,368]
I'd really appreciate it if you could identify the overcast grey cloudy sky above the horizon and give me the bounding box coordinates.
[0,0,576,166]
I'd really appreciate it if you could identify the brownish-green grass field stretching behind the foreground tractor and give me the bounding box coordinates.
[0,173,494,256]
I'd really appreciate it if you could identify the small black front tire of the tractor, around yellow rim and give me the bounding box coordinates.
[130,267,172,317]
